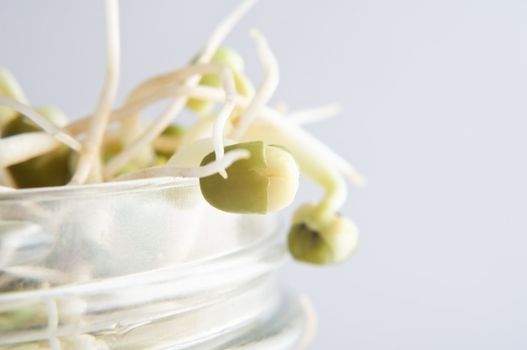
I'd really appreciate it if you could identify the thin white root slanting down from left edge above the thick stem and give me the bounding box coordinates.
[0,96,81,151]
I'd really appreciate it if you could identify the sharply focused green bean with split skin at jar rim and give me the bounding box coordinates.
[200,141,299,214]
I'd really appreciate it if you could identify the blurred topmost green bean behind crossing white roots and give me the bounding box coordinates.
[187,47,254,113]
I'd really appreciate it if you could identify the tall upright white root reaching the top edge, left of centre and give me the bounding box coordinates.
[70,0,120,184]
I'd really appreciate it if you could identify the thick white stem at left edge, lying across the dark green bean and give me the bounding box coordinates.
[0,131,60,168]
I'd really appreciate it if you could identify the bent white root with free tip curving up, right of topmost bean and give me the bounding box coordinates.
[230,30,280,140]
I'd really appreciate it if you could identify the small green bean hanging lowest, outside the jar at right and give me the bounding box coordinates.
[288,204,358,265]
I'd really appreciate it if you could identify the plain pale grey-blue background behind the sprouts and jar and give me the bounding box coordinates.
[0,0,527,349]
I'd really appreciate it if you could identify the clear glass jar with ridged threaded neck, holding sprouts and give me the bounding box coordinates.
[0,178,308,350]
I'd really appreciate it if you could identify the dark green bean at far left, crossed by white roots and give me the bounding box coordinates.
[2,107,72,188]
